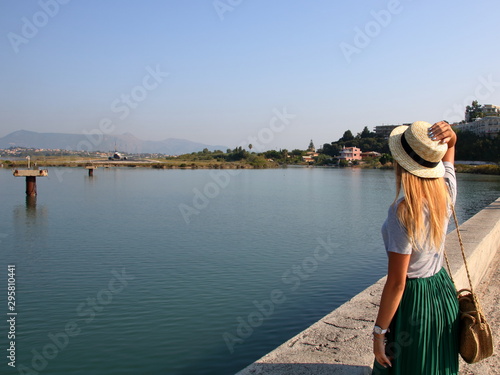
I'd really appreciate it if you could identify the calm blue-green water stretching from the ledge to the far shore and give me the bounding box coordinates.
[0,168,500,375]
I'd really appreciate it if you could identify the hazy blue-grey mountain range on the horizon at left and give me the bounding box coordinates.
[0,130,228,155]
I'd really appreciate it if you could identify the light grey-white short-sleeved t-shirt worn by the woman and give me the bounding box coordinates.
[382,162,457,279]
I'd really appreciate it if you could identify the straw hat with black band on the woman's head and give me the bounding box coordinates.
[389,121,448,178]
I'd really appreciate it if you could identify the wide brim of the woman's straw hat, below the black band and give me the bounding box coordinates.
[389,125,444,178]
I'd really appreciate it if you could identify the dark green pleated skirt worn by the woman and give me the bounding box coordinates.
[372,268,459,375]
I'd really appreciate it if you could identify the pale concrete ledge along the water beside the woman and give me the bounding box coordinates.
[237,198,500,375]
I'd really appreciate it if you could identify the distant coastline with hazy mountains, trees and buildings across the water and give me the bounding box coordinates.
[0,125,500,175]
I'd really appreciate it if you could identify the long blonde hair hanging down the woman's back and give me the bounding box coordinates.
[393,162,451,250]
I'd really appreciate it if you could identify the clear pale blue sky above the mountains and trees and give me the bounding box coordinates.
[0,0,500,150]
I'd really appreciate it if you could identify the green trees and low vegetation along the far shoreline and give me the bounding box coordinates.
[0,127,500,175]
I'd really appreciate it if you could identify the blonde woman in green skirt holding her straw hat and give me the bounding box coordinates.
[373,121,458,375]
